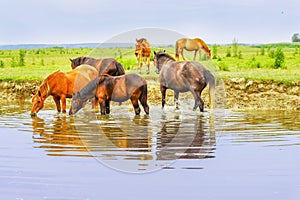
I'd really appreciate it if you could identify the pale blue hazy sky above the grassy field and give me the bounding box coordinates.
[0,0,300,45]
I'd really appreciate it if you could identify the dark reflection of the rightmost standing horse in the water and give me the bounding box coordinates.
[157,114,216,160]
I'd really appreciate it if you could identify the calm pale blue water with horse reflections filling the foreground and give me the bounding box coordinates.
[0,102,300,200]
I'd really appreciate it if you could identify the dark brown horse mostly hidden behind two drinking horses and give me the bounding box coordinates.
[70,56,125,76]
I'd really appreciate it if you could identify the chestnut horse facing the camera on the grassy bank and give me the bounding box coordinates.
[135,38,151,74]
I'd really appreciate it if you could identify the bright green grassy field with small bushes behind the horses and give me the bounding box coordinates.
[0,43,300,84]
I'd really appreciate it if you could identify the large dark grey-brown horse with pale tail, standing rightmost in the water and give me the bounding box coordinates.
[154,52,215,112]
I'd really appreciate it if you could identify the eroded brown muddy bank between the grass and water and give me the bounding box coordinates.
[0,78,300,111]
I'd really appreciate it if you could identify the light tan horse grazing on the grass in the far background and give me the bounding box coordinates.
[175,38,211,60]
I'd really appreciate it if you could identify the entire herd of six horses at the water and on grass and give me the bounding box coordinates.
[30,38,215,116]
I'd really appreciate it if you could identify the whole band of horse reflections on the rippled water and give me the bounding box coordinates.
[32,113,216,161]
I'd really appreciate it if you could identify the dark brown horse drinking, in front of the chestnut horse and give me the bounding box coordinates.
[69,74,149,115]
